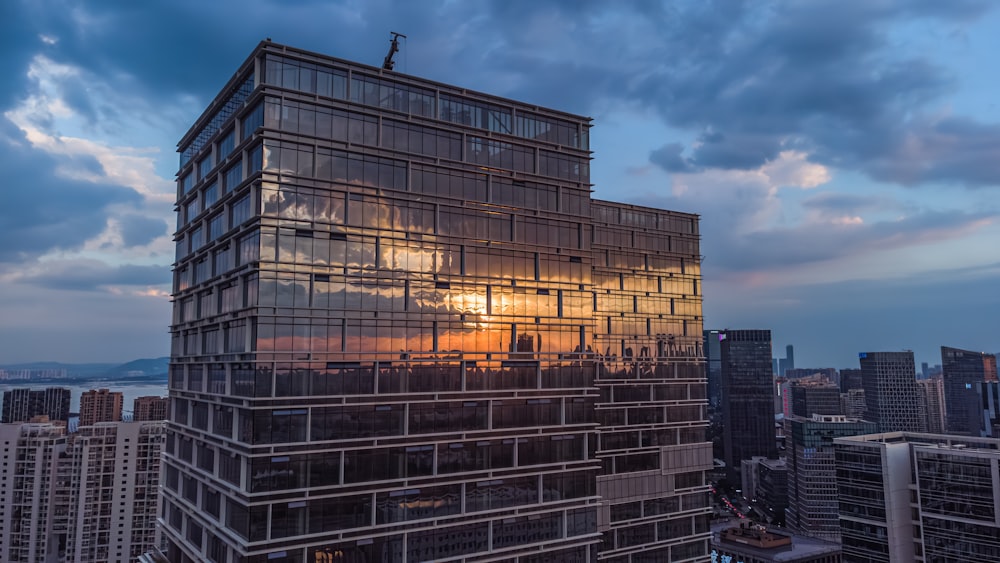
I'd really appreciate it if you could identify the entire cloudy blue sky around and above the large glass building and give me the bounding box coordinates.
[0,0,1000,367]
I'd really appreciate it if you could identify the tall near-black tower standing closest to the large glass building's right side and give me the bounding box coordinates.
[720,330,778,480]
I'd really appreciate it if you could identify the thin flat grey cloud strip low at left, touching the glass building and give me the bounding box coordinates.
[18,260,170,291]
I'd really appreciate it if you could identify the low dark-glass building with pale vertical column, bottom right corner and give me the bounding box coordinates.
[834,432,1000,563]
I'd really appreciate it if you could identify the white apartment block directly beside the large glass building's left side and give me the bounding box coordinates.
[66,421,165,563]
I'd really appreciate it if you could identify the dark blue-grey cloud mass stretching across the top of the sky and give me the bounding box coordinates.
[7,0,998,192]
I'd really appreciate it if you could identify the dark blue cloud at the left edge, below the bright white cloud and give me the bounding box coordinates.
[0,119,142,263]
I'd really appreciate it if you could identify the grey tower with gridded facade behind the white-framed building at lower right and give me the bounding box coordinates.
[859,351,927,432]
